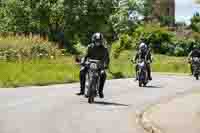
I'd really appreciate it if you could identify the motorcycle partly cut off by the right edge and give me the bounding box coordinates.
[192,57,200,80]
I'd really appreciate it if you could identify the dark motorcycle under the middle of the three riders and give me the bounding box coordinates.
[137,60,149,87]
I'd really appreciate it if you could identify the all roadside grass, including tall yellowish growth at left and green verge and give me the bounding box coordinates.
[0,36,189,87]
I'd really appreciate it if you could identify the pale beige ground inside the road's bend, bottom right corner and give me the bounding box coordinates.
[142,90,200,133]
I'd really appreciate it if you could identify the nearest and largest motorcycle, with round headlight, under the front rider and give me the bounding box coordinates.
[85,59,101,103]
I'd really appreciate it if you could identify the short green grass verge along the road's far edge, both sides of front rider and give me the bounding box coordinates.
[0,51,189,87]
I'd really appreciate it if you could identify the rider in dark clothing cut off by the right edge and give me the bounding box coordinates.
[188,46,200,74]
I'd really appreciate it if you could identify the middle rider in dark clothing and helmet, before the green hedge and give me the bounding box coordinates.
[134,39,152,80]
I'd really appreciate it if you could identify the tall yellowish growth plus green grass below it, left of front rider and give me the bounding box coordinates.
[0,36,79,87]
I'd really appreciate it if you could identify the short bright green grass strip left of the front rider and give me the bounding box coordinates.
[0,57,79,87]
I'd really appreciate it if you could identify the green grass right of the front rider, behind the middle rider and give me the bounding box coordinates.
[109,51,190,78]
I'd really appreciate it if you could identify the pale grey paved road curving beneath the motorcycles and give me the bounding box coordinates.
[0,74,200,133]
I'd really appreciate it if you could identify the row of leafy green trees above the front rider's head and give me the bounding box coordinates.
[0,0,150,49]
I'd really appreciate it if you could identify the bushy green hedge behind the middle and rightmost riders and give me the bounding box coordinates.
[114,24,200,57]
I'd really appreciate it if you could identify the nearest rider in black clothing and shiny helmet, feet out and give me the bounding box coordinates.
[78,33,110,98]
